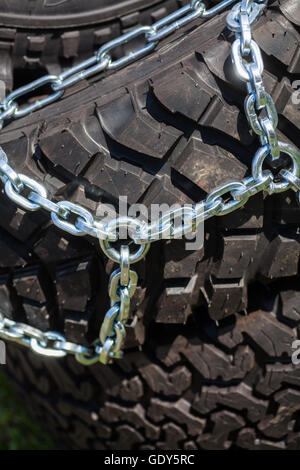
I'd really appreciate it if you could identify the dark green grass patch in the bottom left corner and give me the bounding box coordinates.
[0,366,56,450]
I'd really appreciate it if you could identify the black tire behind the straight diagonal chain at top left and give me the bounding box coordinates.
[0,0,188,91]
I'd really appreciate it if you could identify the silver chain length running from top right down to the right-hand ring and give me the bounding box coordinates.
[227,0,300,199]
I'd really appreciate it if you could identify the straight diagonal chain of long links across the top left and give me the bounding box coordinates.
[0,0,237,126]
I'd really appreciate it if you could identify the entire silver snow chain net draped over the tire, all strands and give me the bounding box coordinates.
[0,0,300,365]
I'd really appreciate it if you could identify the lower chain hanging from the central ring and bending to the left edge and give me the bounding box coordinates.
[0,246,138,365]
